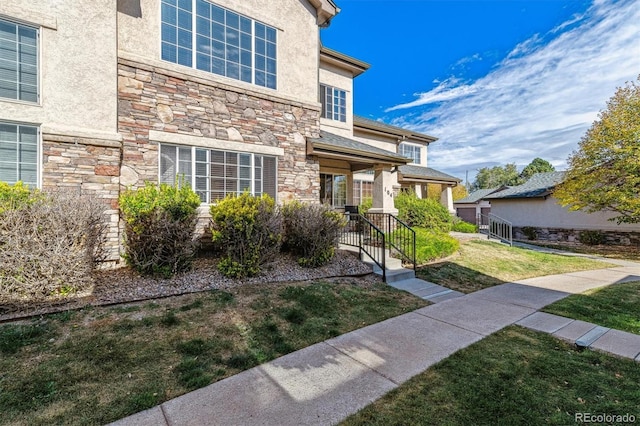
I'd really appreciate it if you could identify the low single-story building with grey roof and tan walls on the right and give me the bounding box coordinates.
[484,172,640,244]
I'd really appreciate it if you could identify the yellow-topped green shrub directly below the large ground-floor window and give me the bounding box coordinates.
[210,193,282,278]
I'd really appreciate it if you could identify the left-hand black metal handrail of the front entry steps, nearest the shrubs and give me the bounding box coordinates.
[340,213,387,282]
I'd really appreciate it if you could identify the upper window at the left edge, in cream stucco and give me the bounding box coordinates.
[0,19,38,102]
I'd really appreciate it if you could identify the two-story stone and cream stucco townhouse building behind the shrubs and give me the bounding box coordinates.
[0,0,458,259]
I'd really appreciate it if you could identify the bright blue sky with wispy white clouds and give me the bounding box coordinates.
[321,0,640,181]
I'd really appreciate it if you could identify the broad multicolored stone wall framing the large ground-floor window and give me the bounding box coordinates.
[118,58,320,203]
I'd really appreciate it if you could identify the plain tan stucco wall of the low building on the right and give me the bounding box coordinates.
[491,197,640,231]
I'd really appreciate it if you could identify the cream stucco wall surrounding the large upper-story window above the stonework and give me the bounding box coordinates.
[118,0,320,103]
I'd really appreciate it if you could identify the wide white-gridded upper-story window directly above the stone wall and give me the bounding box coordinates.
[162,0,277,89]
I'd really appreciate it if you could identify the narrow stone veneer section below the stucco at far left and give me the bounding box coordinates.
[42,133,121,261]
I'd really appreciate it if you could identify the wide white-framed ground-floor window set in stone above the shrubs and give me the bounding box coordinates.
[160,144,278,203]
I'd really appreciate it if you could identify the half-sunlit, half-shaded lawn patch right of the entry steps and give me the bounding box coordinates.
[417,240,613,293]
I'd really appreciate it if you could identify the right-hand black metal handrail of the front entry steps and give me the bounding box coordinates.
[366,213,416,271]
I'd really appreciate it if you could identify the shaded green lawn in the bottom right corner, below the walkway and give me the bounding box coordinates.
[342,326,640,426]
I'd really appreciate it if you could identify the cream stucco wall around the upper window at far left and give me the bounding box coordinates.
[0,0,117,139]
